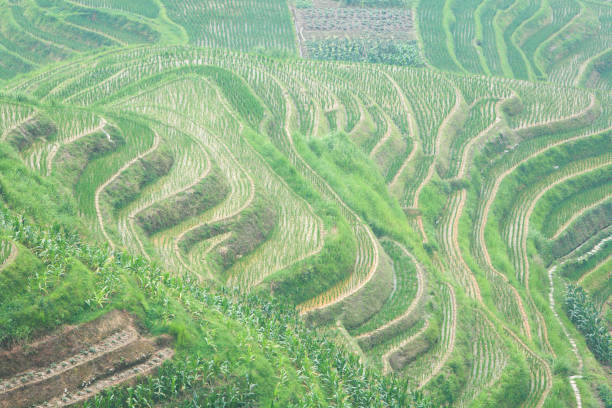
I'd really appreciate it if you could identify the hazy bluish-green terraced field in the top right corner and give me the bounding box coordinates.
[415,0,612,86]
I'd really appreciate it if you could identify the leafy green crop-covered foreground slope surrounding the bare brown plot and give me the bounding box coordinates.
[0,139,432,407]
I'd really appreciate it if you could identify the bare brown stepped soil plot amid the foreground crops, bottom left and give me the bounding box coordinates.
[0,311,174,408]
